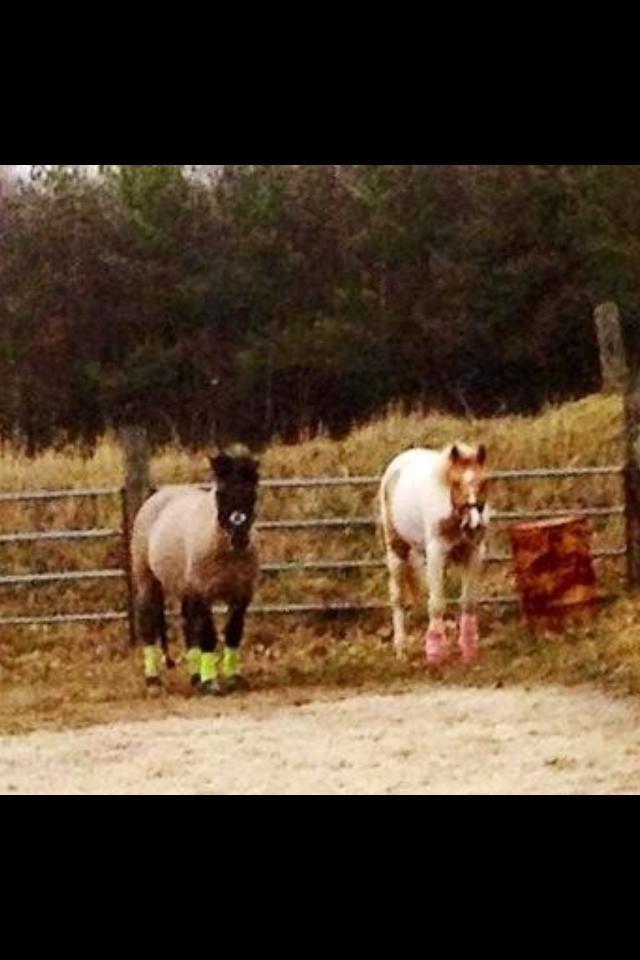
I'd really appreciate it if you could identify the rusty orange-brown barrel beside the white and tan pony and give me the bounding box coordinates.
[509,517,602,629]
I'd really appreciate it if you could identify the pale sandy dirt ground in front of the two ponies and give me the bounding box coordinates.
[0,687,640,795]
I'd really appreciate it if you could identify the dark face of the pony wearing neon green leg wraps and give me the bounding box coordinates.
[210,453,260,550]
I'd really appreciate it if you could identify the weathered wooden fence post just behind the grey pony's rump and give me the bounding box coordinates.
[119,426,151,646]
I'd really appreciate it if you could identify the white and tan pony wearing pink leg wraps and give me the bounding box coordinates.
[380,444,489,665]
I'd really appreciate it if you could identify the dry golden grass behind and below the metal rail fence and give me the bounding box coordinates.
[0,397,640,729]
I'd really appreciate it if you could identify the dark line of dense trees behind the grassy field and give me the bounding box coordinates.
[0,164,640,452]
